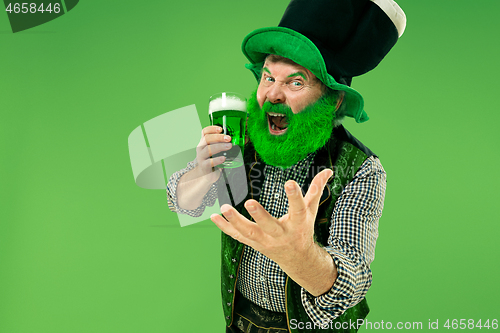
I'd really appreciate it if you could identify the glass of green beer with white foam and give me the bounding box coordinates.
[208,92,247,168]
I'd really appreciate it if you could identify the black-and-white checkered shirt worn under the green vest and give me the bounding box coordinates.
[167,153,386,324]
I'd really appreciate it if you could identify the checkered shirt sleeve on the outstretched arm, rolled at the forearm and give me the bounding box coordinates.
[301,156,386,324]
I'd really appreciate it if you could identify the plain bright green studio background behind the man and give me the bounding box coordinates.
[0,0,500,333]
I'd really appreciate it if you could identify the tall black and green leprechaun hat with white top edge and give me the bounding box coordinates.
[242,0,406,123]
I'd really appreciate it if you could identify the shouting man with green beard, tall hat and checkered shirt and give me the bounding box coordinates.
[167,0,404,332]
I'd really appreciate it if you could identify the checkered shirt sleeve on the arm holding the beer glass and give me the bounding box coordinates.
[167,160,217,217]
